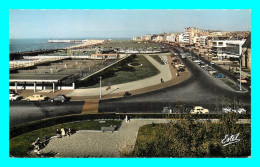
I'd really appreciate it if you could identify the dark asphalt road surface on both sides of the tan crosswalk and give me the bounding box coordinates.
[10,47,251,127]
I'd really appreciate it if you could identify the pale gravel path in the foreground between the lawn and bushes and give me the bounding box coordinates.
[38,119,168,157]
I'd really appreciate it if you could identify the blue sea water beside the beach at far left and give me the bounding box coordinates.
[9,39,78,53]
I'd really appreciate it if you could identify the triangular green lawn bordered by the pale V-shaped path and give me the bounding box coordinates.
[87,55,159,88]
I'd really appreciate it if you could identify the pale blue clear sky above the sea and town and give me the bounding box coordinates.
[9,9,251,39]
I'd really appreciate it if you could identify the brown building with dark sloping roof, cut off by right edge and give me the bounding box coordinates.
[242,33,251,70]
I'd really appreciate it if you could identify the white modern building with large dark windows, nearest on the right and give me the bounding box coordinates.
[211,39,245,60]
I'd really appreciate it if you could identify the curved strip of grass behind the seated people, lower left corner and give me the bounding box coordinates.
[9,120,122,157]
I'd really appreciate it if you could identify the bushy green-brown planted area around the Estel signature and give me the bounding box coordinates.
[133,121,251,157]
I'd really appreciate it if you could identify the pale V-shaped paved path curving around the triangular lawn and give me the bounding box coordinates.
[67,53,172,96]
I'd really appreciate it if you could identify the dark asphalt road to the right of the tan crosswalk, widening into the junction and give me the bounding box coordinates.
[99,47,251,113]
